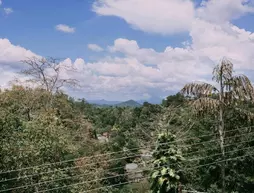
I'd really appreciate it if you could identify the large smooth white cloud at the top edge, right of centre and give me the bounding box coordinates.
[93,0,195,35]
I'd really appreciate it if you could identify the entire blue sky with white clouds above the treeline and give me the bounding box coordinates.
[0,0,254,102]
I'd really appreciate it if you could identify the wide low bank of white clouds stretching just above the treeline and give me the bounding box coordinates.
[0,25,254,100]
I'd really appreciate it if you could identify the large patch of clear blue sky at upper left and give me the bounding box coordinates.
[0,0,188,60]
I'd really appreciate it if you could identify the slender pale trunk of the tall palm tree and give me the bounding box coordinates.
[219,69,226,193]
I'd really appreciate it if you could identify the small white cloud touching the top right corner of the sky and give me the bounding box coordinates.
[197,0,254,22]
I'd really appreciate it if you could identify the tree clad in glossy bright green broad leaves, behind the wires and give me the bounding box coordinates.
[151,133,184,193]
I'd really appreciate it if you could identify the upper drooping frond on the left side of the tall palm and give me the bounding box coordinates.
[181,82,218,97]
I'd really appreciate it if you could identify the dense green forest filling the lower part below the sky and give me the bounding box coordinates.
[0,55,254,193]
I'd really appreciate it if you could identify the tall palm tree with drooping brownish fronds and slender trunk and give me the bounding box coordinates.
[181,58,254,193]
